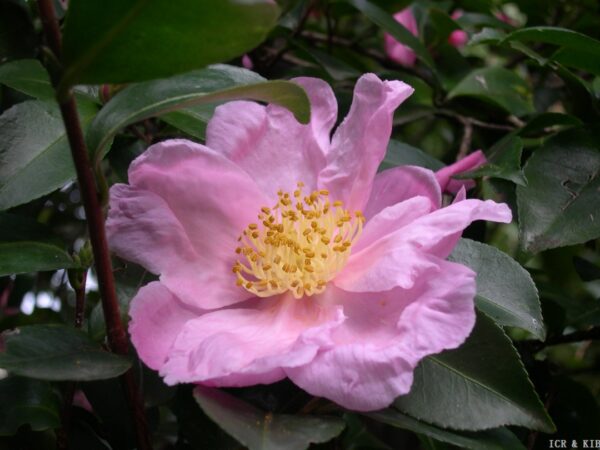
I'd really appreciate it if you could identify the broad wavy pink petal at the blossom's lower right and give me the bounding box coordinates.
[285,258,475,411]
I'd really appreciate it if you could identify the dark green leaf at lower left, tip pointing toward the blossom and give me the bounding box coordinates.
[0,325,131,381]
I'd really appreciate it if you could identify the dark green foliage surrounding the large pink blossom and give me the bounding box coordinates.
[0,0,600,450]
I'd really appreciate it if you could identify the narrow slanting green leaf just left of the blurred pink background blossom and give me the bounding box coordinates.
[347,0,435,69]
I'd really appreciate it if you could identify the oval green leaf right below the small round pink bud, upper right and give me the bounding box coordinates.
[448,67,534,116]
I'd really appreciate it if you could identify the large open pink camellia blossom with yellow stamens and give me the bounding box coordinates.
[107,74,511,411]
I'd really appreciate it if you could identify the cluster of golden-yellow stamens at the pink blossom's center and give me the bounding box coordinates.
[232,182,365,298]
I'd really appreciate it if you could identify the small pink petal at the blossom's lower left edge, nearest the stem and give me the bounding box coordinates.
[129,281,199,370]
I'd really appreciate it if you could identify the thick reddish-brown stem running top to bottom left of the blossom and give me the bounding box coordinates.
[38,0,152,450]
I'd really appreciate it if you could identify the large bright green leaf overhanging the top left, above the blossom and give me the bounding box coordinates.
[63,0,279,85]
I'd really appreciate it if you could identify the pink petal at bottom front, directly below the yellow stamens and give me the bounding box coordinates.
[161,295,343,386]
